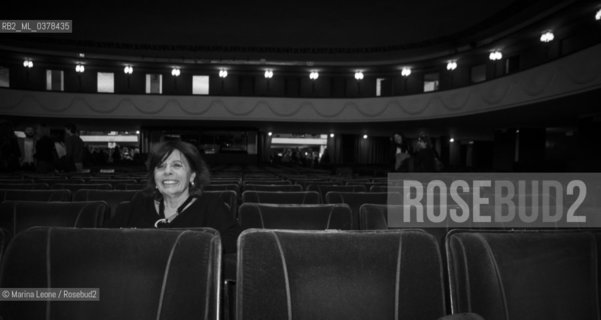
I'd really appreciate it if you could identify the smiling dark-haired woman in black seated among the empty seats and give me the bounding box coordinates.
[111,141,241,252]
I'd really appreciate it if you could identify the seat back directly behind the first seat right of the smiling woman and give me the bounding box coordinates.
[242,190,321,204]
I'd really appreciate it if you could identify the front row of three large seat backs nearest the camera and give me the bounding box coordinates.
[0,227,601,320]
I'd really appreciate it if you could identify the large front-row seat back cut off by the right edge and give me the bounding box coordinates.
[446,230,600,320]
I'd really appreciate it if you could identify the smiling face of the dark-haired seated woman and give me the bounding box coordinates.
[154,149,196,197]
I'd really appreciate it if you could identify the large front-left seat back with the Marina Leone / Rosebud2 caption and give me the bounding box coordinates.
[0,228,221,320]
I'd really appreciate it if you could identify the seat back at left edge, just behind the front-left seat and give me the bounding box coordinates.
[0,201,110,235]
